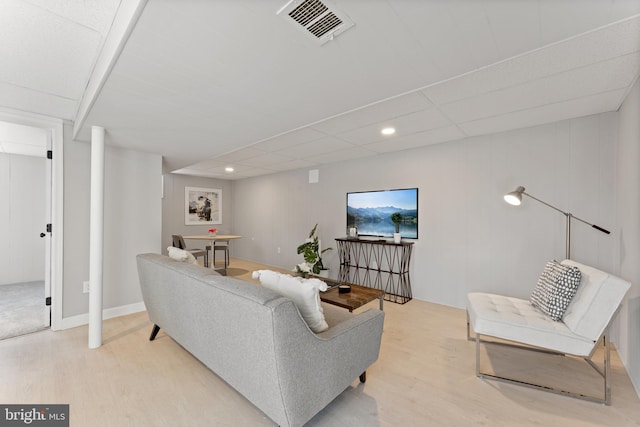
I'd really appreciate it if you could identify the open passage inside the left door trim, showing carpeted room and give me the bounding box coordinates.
[0,122,51,339]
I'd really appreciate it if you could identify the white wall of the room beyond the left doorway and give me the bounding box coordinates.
[0,153,47,285]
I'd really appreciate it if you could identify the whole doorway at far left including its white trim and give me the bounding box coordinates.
[0,110,63,339]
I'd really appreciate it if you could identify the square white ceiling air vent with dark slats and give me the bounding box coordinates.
[277,0,354,44]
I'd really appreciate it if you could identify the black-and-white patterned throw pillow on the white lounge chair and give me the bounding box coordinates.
[529,261,582,320]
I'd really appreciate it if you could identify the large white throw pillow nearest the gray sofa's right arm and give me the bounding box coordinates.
[252,270,329,333]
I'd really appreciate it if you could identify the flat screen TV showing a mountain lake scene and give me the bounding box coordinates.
[347,188,418,239]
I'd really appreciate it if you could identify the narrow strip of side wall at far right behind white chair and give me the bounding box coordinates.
[615,76,640,395]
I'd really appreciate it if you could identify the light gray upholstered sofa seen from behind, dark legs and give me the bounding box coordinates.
[137,254,384,426]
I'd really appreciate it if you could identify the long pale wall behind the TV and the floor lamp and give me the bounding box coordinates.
[233,114,618,307]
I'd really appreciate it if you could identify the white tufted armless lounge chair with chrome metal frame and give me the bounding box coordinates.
[467,260,631,404]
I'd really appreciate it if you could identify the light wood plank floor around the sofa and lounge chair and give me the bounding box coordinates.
[0,259,640,427]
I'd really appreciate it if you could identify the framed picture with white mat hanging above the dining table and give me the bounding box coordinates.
[184,187,222,225]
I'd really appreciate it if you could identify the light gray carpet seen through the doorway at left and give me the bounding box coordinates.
[0,281,48,340]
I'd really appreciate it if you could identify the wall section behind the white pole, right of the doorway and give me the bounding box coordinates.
[63,127,162,320]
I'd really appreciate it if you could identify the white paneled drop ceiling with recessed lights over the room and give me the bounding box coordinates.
[0,0,640,179]
